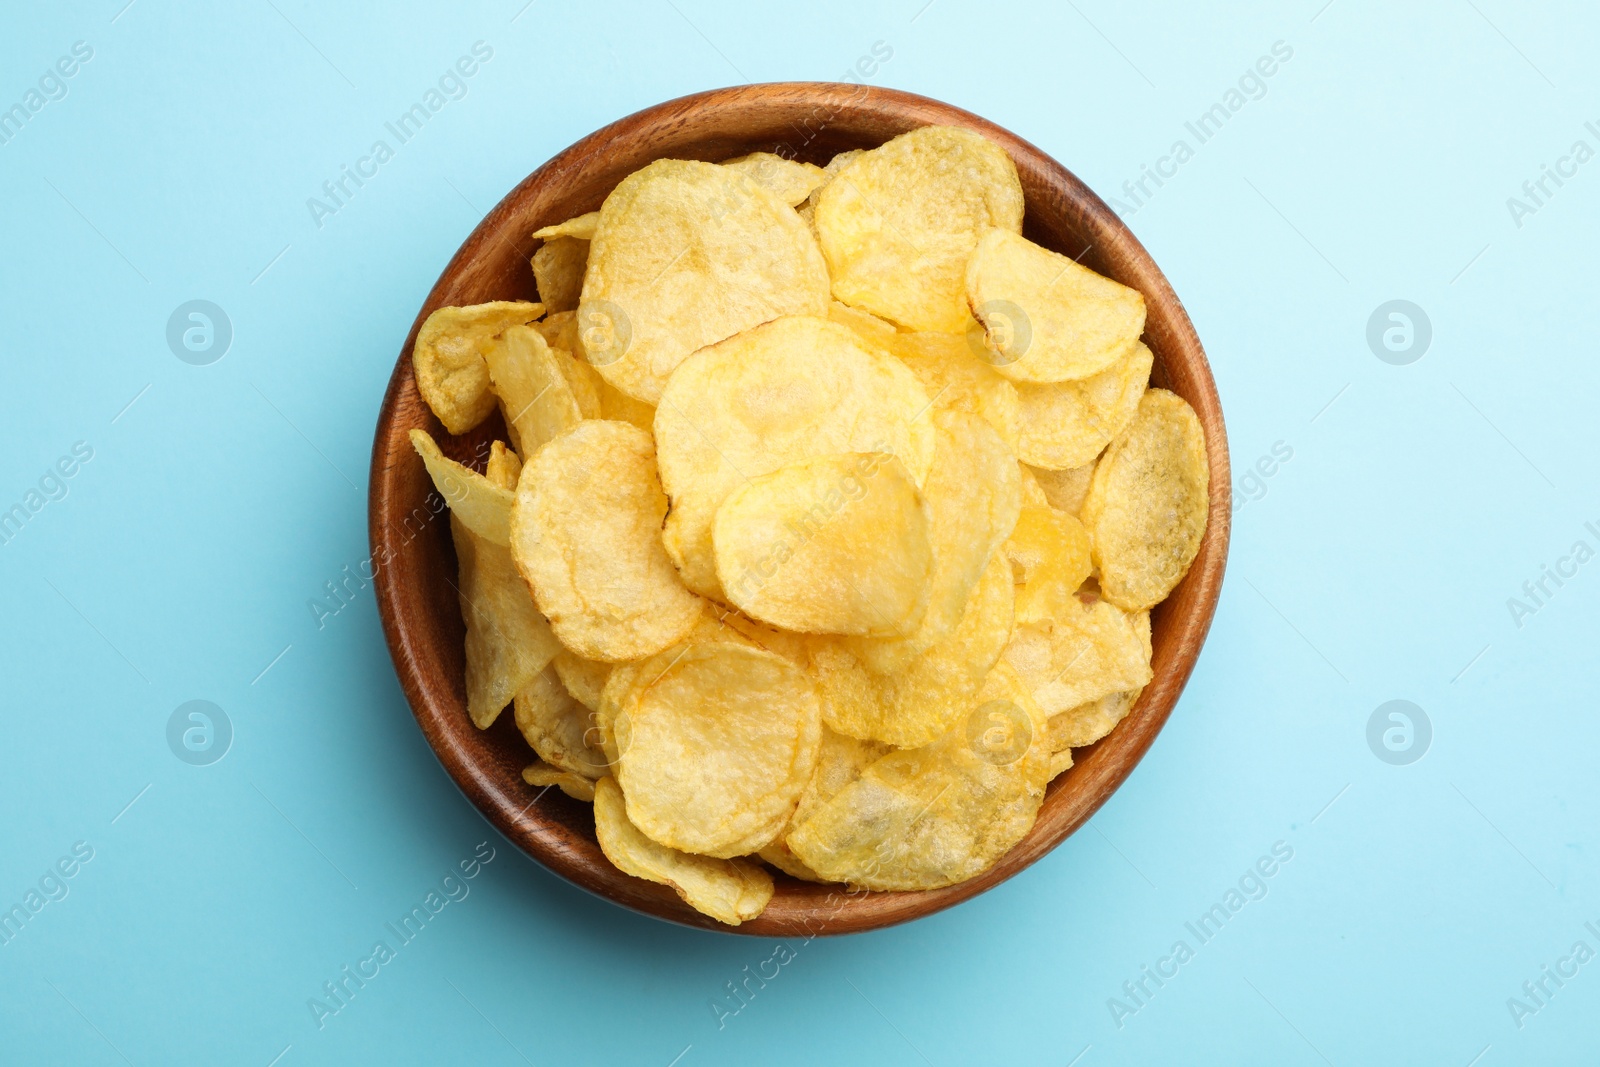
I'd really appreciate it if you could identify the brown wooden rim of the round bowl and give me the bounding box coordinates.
[368,82,1232,936]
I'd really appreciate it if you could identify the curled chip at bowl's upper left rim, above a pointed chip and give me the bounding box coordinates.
[411,301,544,434]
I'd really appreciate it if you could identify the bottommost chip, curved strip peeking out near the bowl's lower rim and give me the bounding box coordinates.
[594,777,773,926]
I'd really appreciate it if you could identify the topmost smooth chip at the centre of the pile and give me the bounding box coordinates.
[712,453,933,635]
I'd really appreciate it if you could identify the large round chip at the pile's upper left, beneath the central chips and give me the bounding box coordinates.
[578,160,827,403]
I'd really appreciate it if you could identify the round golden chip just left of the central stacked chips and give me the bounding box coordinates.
[510,419,704,662]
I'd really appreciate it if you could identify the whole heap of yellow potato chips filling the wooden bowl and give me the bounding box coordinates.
[411,126,1208,923]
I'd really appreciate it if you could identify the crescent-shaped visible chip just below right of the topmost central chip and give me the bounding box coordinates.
[808,552,1011,749]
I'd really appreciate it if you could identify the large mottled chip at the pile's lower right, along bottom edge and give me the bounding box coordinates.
[787,664,1051,889]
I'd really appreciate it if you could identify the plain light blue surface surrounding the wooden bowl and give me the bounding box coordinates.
[0,0,1600,1067]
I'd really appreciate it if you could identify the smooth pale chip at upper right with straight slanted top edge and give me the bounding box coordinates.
[965,229,1144,385]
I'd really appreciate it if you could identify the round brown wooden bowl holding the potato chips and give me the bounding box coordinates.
[368,83,1230,936]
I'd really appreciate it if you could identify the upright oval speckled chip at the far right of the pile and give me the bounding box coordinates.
[1083,389,1211,611]
